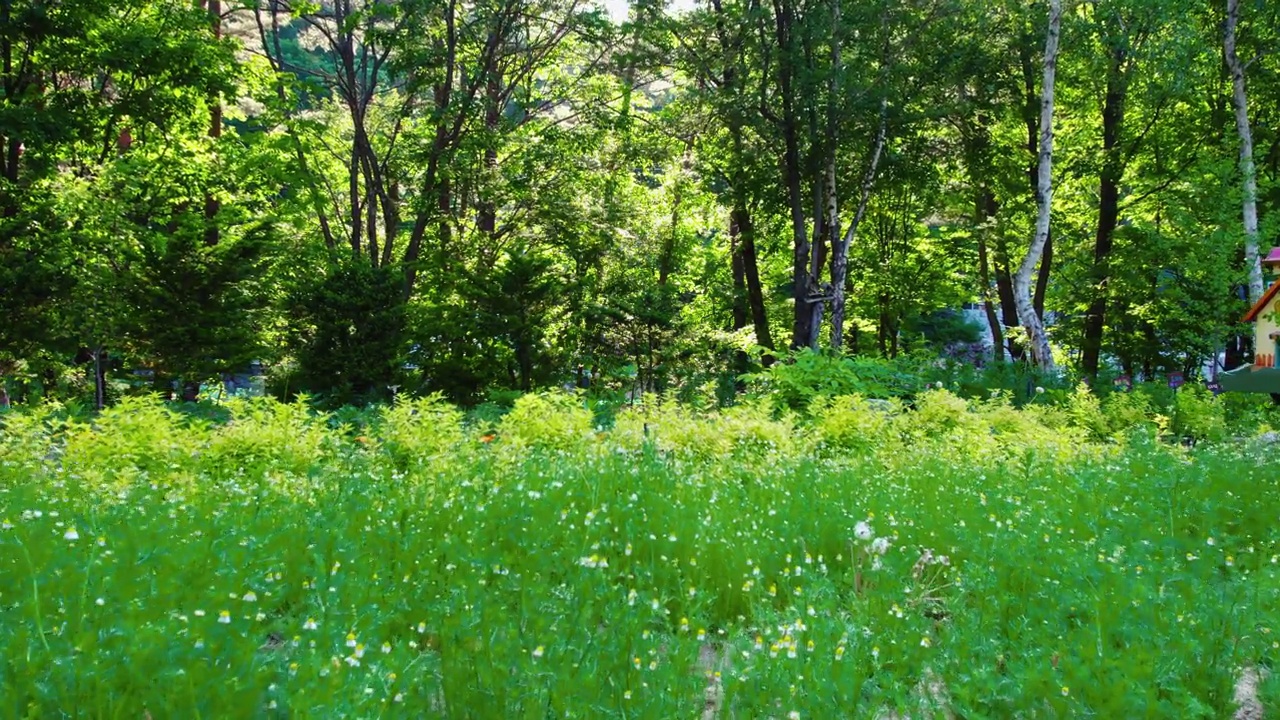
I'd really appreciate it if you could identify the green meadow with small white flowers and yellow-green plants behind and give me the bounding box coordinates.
[0,391,1280,719]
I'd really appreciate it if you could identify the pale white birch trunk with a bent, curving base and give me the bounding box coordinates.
[1014,0,1062,370]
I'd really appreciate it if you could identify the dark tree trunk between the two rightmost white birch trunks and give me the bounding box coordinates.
[1080,50,1128,377]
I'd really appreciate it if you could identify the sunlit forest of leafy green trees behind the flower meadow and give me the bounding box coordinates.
[0,0,1280,405]
